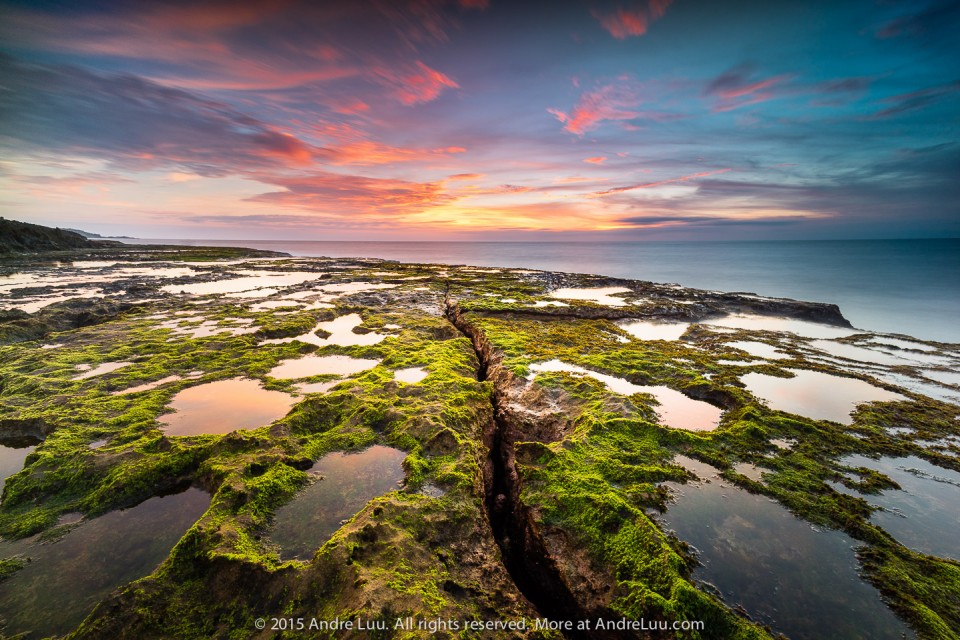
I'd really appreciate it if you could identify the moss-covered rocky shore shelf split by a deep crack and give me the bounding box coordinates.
[0,247,960,638]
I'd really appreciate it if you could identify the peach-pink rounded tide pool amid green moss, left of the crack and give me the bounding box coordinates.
[158,378,297,436]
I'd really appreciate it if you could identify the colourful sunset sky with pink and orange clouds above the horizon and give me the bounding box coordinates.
[0,0,960,241]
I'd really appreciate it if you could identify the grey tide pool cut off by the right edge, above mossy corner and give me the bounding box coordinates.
[835,455,960,560]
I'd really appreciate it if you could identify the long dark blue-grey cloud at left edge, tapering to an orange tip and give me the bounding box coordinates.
[0,55,327,176]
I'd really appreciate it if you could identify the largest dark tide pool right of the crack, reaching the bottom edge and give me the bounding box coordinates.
[659,456,913,639]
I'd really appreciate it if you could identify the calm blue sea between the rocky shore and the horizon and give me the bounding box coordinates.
[129,240,960,342]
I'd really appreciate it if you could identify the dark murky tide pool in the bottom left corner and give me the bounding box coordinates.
[0,489,210,638]
